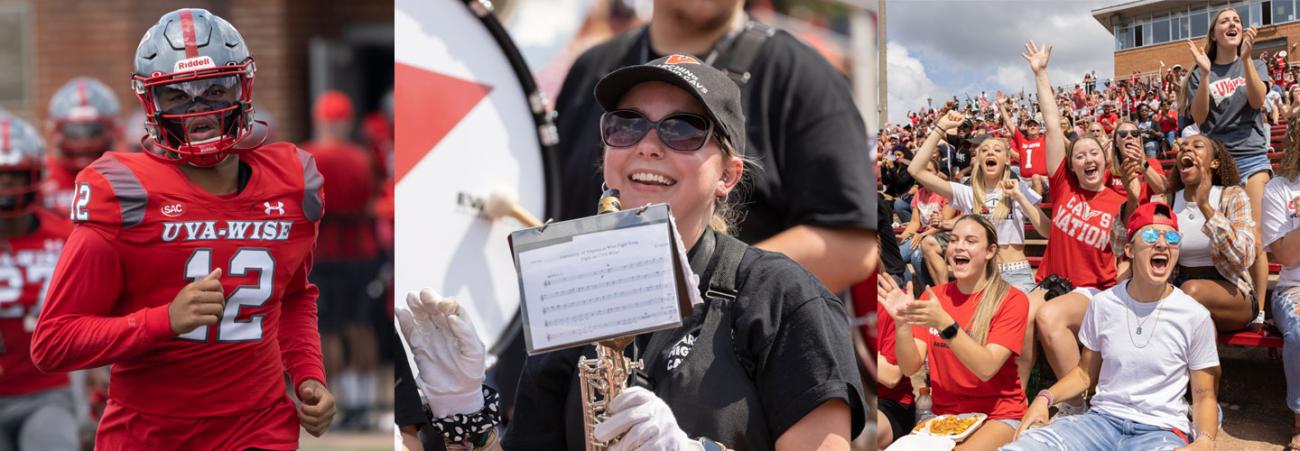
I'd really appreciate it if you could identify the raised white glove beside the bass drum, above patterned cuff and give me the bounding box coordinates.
[395,289,485,419]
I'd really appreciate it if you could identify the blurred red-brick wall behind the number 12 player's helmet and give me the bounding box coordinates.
[0,0,393,142]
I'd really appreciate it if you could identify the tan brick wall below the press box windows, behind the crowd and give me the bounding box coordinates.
[1102,22,1300,79]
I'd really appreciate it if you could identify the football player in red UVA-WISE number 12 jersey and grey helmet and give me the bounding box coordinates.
[31,9,334,450]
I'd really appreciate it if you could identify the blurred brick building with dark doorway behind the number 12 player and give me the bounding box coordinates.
[0,0,393,142]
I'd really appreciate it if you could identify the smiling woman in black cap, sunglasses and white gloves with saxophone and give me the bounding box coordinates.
[398,55,865,450]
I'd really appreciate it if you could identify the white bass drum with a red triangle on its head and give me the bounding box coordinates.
[394,0,558,369]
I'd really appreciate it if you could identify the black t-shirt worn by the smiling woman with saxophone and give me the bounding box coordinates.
[502,231,866,450]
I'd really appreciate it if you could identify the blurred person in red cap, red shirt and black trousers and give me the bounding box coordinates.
[303,91,380,428]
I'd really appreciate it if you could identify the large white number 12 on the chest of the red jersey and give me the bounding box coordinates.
[179,247,276,343]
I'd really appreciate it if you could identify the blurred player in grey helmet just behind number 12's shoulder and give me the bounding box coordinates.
[40,77,122,216]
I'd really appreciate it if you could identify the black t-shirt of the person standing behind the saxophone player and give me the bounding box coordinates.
[546,27,876,243]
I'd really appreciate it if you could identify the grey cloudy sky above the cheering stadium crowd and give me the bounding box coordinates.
[885,0,1126,123]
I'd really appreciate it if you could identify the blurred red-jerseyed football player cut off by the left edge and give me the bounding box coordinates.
[0,112,78,451]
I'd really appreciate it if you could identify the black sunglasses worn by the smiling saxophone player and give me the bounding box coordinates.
[601,109,714,152]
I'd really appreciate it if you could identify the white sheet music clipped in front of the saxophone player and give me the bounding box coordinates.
[519,222,680,350]
